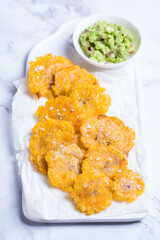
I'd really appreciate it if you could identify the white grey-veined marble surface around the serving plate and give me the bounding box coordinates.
[0,0,160,240]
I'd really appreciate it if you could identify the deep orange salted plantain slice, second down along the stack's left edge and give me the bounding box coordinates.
[36,96,81,131]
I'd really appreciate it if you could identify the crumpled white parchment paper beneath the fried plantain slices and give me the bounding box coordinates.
[12,64,148,221]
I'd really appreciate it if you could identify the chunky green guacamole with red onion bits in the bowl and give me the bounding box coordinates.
[79,21,134,63]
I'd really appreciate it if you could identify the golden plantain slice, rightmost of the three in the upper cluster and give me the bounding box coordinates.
[71,85,111,119]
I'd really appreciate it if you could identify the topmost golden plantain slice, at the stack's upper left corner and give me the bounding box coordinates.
[28,54,72,98]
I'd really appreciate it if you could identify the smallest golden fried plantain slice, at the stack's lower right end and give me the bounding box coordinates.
[111,170,145,202]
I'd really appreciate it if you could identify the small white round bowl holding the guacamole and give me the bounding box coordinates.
[73,14,141,68]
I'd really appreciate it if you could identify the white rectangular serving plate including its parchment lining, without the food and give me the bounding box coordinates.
[13,19,148,223]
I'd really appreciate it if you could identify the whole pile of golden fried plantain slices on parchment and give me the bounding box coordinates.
[29,54,144,215]
